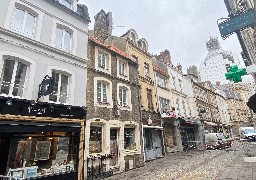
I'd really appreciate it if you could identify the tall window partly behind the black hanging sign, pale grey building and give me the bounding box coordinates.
[49,71,69,103]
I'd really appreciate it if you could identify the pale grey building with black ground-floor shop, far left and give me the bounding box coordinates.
[0,0,90,179]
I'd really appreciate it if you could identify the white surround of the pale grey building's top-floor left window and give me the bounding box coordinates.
[4,0,44,41]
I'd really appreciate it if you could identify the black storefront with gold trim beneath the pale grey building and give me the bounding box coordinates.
[0,97,85,179]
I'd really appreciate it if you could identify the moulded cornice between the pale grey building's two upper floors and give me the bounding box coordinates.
[0,27,87,68]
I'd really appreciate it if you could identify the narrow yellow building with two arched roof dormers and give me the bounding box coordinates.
[113,29,164,160]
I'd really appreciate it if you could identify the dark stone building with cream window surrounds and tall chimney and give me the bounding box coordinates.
[85,10,144,178]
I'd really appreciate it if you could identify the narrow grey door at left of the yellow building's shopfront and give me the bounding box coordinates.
[144,129,156,161]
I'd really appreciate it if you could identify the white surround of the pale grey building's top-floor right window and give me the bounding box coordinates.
[51,19,77,55]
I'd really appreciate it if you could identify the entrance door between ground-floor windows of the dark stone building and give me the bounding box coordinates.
[110,128,119,167]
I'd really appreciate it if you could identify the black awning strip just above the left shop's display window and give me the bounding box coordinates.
[0,121,81,133]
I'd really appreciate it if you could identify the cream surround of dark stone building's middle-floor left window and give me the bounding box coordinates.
[94,77,113,108]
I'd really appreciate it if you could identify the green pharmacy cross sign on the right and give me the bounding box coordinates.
[225,65,247,83]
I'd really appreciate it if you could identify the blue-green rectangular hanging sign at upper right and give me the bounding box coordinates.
[218,9,256,38]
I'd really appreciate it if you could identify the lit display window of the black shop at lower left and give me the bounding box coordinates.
[5,132,80,179]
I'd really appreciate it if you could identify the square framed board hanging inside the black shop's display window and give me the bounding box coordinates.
[35,141,51,160]
